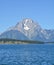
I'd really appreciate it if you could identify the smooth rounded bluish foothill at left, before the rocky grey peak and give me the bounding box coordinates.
[0,30,28,40]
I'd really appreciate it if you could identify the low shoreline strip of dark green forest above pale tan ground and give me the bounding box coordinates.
[0,39,44,44]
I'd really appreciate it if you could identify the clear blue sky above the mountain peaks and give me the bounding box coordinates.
[0,0,54,32]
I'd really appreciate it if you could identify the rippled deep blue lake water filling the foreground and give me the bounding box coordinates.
[0,44,54,65]
